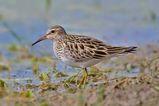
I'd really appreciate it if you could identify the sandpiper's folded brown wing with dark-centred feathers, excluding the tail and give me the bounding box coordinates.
[62,35,107,62]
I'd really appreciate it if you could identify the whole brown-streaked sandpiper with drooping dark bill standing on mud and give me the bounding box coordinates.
[32,25,137,85]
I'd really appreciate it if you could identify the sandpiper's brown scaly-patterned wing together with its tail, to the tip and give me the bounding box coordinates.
[62,35,136,62]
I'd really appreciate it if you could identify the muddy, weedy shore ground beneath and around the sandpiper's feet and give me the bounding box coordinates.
[0,44,159,106]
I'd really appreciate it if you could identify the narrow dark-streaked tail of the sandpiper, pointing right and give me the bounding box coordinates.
[107,47,137,54]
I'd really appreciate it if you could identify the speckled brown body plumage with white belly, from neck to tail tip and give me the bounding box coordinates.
[46,26,136,68]
